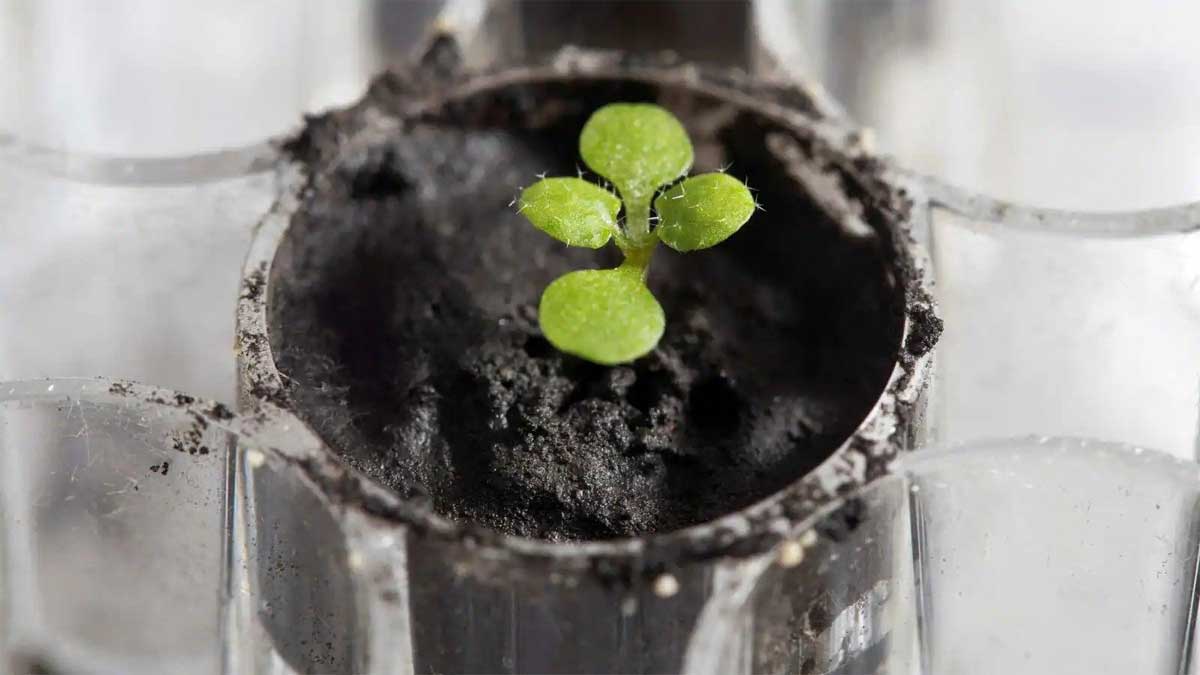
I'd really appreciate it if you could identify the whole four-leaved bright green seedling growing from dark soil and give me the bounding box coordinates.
[517,103,756,365]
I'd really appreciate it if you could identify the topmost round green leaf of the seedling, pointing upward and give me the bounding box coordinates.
[580,103,692,203]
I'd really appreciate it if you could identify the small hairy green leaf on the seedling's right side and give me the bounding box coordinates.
[654,173,755,252]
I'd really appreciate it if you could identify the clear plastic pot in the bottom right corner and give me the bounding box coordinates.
[686,437,1200,675]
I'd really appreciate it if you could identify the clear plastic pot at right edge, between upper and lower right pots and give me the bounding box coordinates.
[912,181,1200,458]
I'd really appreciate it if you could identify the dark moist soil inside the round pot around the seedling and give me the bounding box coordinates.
[268,73,902,539]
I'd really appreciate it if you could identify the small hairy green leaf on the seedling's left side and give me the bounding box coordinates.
[520,178,620,249]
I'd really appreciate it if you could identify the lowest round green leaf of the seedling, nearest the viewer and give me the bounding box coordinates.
[538,267,666,365]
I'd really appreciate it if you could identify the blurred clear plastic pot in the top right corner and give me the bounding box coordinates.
[761,0,1200,210]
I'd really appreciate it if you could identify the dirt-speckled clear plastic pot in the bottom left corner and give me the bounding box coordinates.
[0,378,368,675]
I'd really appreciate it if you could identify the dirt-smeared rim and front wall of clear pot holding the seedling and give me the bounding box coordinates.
[238,50,936,673]
